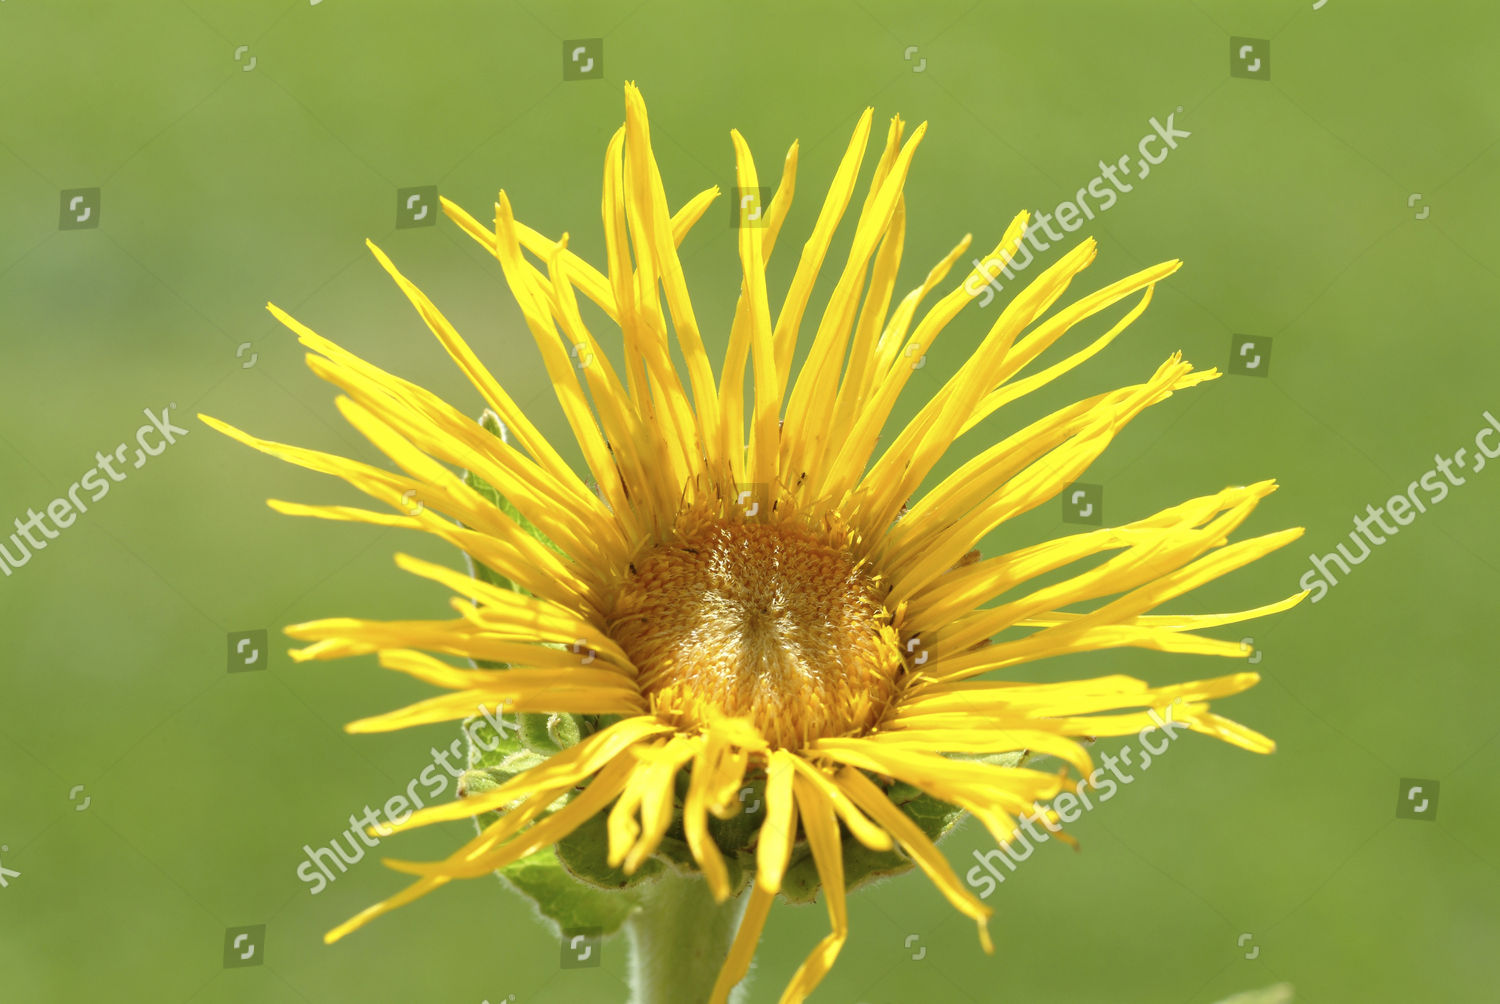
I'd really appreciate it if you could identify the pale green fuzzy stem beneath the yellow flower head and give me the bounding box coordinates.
[626,867,749,1004]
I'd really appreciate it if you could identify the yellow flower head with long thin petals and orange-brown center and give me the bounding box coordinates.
[204,86,1302,1001]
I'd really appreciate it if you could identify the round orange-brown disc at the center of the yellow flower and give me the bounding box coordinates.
[609,512,903,747]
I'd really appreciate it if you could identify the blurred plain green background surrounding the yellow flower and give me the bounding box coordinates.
[0,0,1500,1004]
